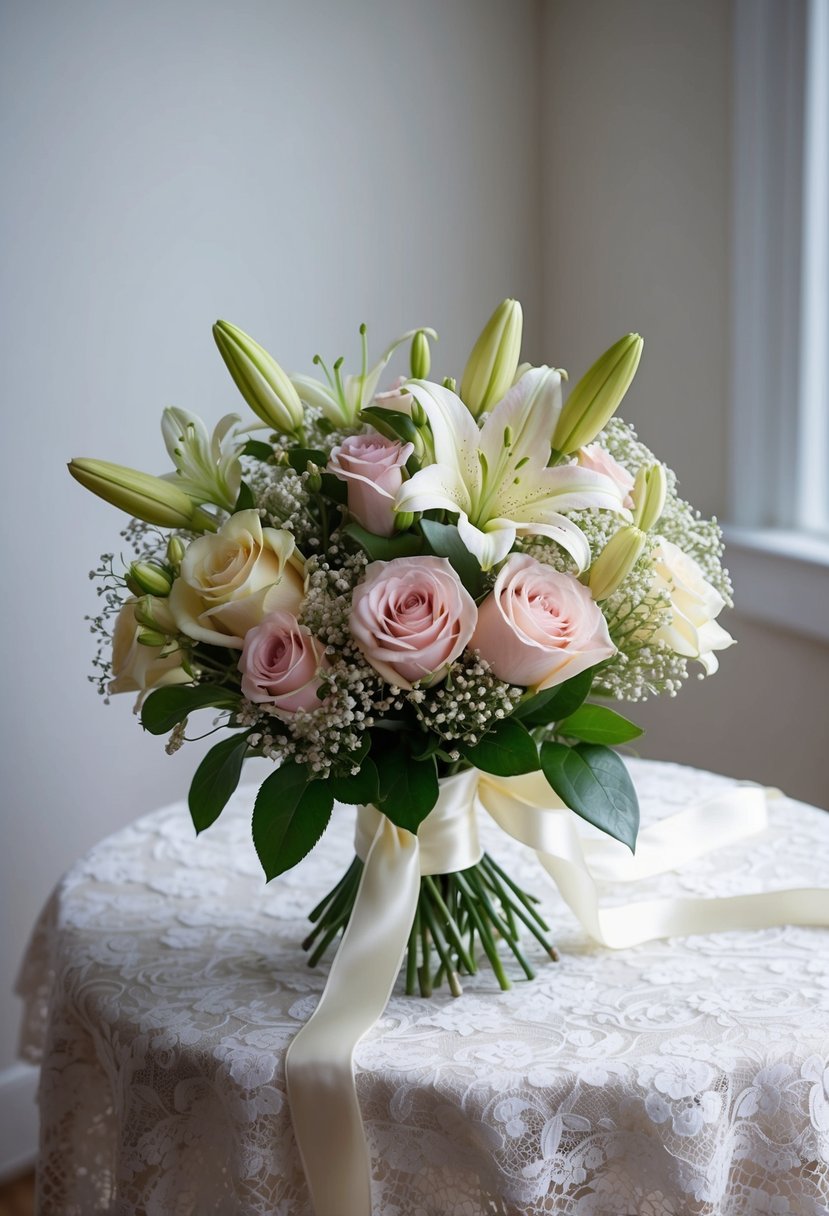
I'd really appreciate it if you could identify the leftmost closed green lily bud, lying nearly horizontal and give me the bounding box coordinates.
[68,457,206,530]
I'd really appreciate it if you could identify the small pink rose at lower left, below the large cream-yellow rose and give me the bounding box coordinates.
[238,612,328,719]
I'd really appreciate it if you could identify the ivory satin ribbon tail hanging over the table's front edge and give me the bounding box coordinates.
[286,817,421,1216]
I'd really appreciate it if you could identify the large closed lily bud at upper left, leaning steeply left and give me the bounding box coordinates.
[213,321,304,434]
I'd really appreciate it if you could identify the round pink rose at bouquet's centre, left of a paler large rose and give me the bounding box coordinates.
[350,557,478,688]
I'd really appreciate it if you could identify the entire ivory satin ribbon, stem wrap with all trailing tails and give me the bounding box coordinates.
[286,770,829,1216]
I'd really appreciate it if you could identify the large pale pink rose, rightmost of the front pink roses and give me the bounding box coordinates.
[470,553,616,689]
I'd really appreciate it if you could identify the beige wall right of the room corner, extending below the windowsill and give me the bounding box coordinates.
[542,0,829,805]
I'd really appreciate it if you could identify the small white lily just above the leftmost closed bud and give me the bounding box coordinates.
[162,406,246,511]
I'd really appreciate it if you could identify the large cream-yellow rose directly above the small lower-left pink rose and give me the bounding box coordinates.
[169,511,304,651]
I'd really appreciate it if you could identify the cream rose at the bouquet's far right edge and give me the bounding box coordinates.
[654,537,734,676]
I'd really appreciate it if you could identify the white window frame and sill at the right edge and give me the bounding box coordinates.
[724,0,829,641]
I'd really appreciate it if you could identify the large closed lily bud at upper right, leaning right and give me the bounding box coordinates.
[553,333,644,456]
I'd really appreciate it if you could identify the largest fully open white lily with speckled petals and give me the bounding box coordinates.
[395,367,630,570]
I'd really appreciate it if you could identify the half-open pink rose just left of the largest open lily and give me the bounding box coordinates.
[328,434,415,536]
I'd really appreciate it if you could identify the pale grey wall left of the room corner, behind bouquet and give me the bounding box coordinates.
[0,0,541,1104]
